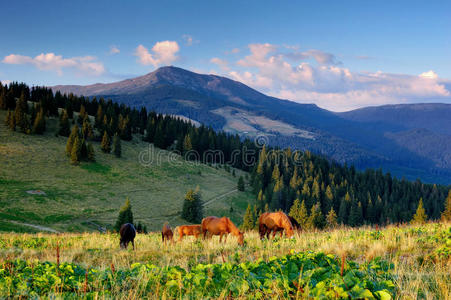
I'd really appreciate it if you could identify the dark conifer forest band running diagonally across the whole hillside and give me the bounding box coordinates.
[0,79,449,227]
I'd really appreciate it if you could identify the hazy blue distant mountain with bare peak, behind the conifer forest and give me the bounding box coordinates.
[52,67,451,184]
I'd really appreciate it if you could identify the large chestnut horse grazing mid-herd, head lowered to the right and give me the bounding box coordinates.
[202,217,244,245]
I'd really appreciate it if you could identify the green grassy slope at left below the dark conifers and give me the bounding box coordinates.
[0,111,254,231]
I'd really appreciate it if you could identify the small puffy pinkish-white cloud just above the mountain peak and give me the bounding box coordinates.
[135,41,180,67]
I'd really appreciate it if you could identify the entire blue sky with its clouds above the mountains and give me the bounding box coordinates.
[0,0,451,110]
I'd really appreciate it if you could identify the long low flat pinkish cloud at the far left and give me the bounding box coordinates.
[2,53,105,75]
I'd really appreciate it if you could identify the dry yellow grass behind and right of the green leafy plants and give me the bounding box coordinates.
[0,223,451,299]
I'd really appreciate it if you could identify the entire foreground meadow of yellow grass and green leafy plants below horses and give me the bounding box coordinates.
[0,223,451,299]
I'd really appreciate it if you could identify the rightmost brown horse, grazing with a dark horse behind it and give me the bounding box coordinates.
[258,211,294,239]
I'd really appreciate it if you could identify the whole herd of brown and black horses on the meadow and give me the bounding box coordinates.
[119,211,300,249]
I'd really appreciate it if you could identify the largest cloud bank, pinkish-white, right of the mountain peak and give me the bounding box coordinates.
[211,43,451,111]
